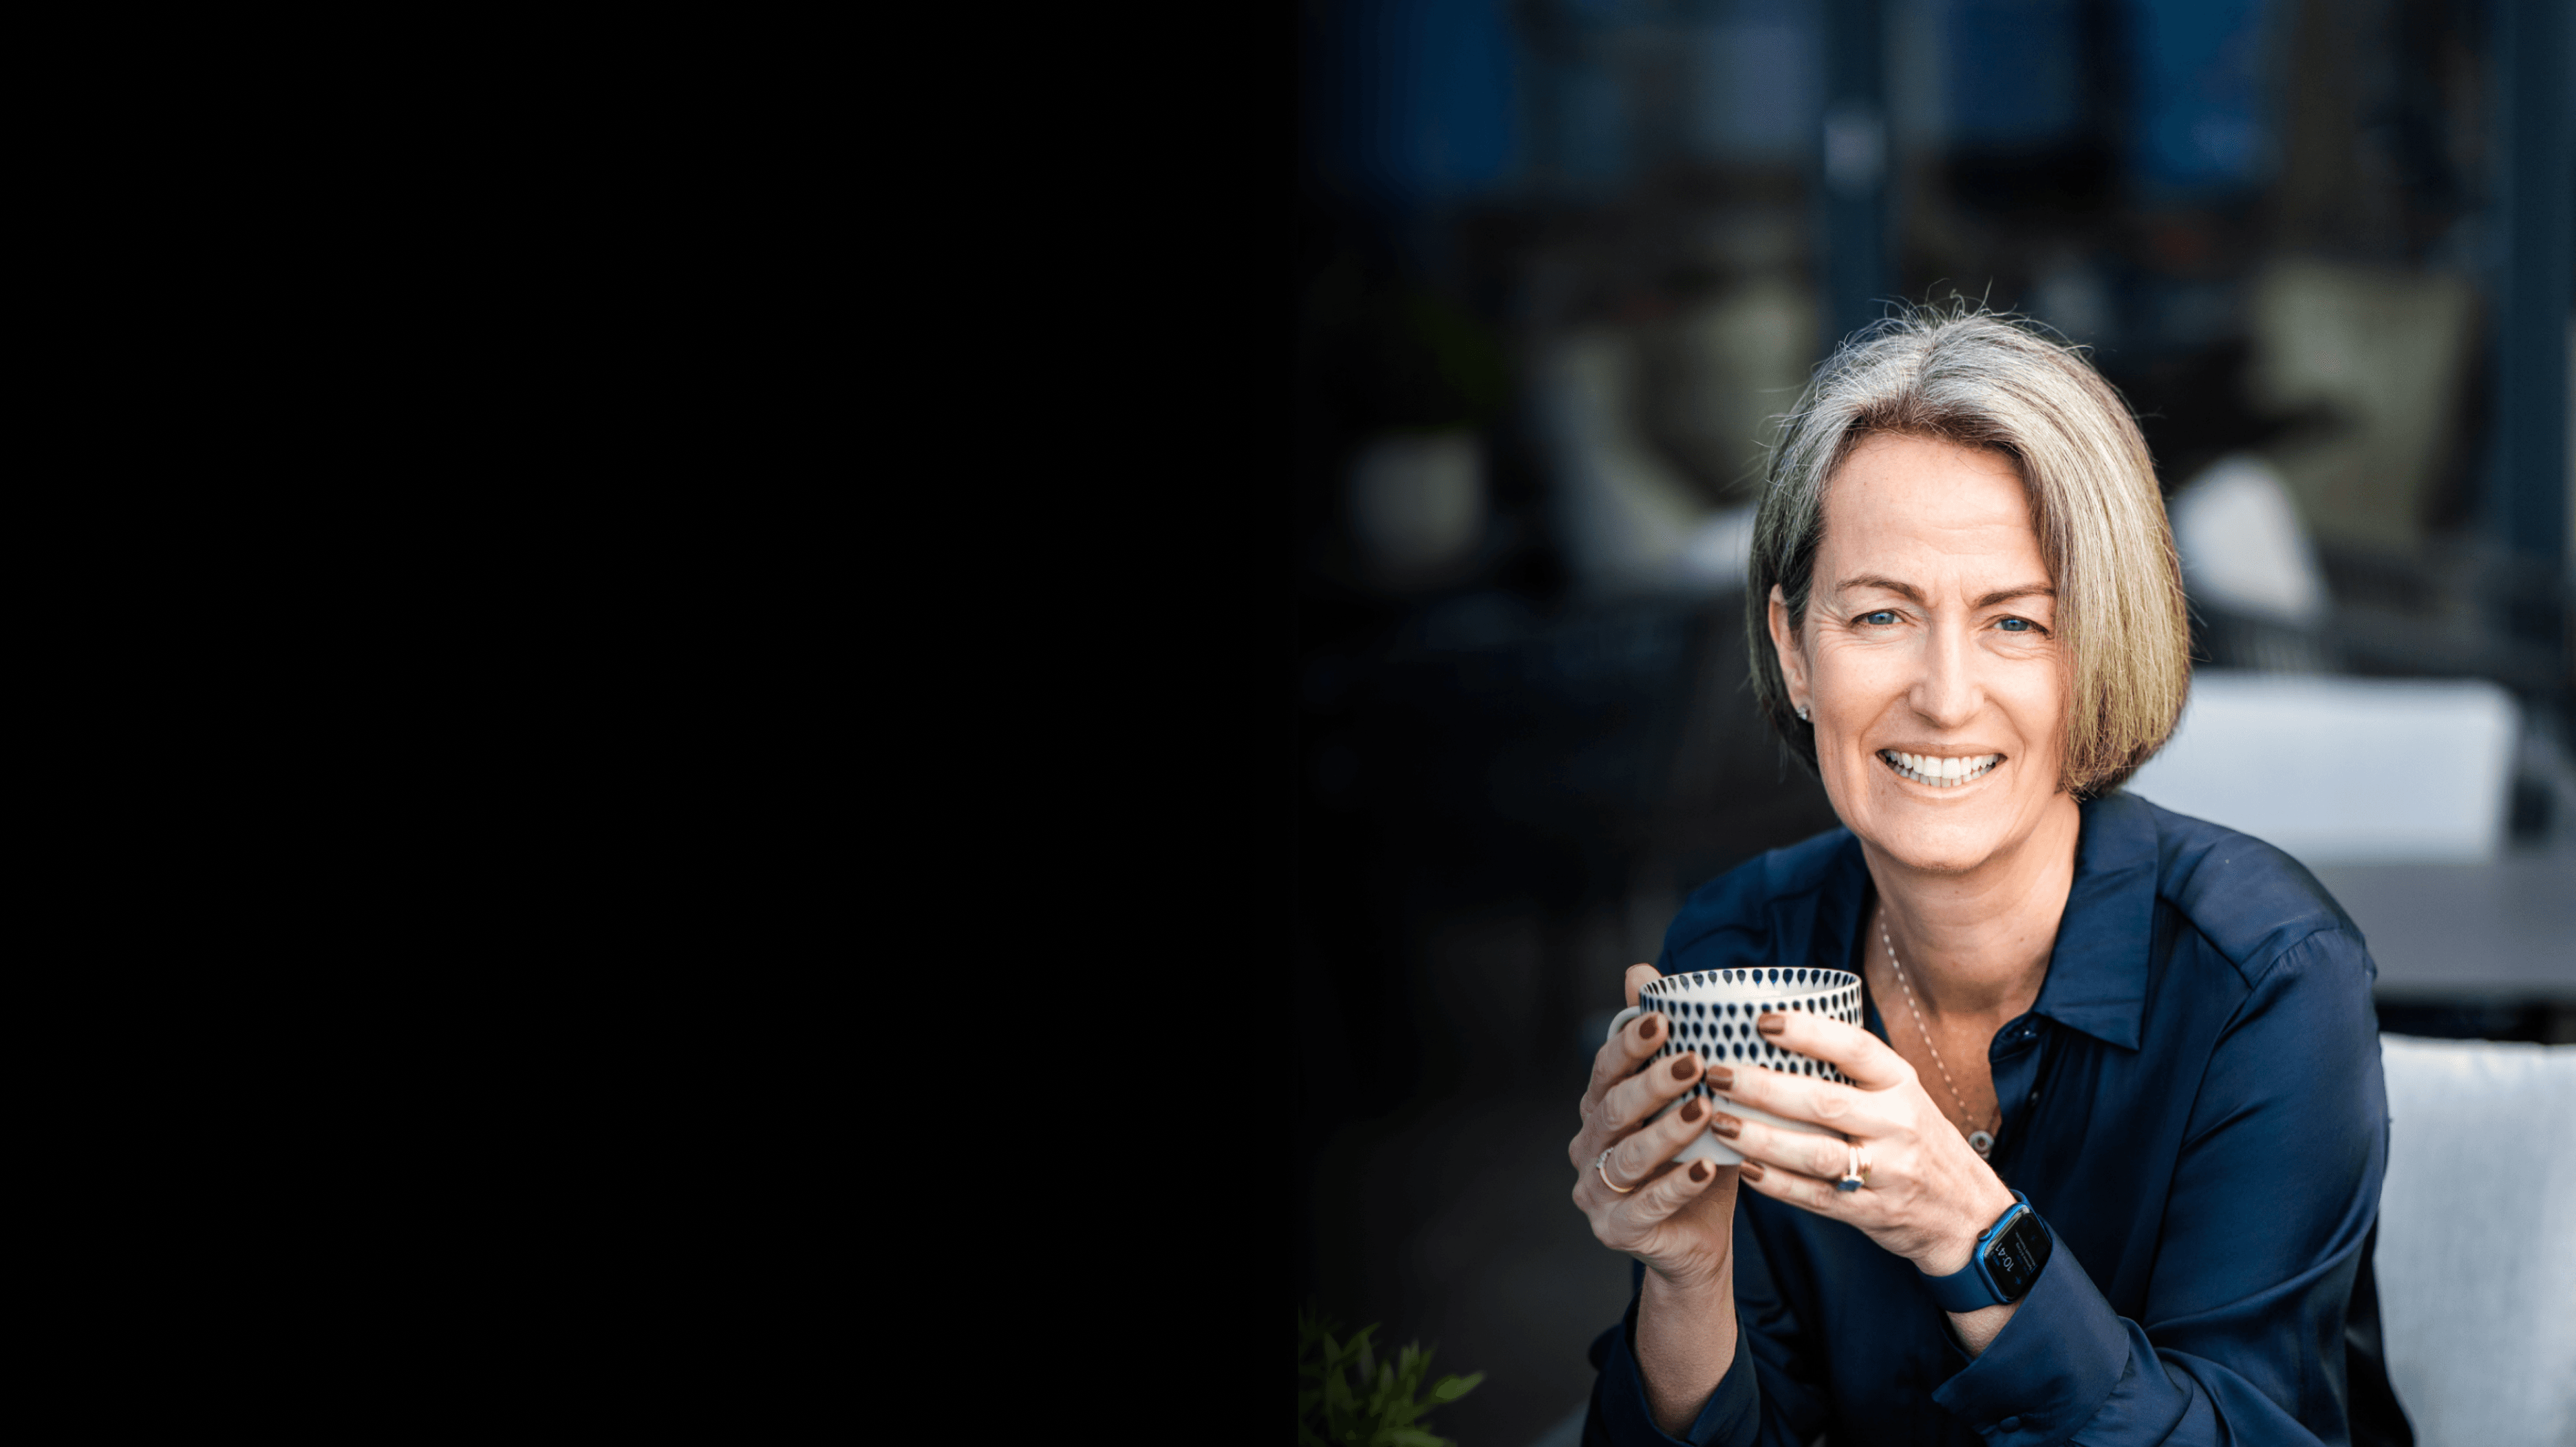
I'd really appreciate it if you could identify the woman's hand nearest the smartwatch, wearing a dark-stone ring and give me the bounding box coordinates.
[1708,1012,2012,1277]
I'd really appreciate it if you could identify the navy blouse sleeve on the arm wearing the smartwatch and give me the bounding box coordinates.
[1932,932,2388,1447]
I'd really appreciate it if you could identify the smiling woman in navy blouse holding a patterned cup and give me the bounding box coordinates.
[1569,314,2409,1447]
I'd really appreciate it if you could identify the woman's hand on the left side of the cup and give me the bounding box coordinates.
[1566,965,1736,1282]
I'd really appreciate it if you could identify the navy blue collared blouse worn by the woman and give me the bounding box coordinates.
[1585,793,2411,1447]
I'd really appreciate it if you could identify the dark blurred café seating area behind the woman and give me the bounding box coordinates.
[1293,0,2576,1447]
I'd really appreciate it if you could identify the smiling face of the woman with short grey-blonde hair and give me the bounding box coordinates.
[1770,435,2066,873]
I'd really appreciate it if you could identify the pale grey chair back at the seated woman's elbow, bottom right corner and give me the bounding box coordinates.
[2375,1035,2576,1447]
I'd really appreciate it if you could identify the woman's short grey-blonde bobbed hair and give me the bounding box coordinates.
[1744,306,2192,798]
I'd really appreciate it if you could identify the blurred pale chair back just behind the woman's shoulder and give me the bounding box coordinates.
[2128,669,2520,865]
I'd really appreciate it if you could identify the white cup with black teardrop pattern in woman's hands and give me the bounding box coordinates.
[1610,968,1860,1166]
